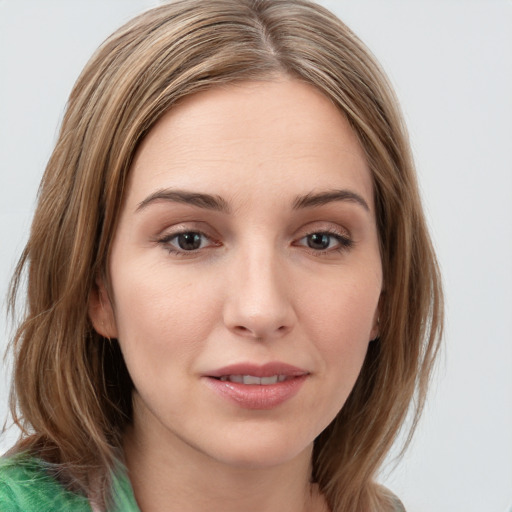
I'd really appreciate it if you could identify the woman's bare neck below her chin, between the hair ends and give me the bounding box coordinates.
[125,414,327,512]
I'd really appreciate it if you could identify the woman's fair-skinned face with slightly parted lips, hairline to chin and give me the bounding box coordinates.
[90,77,382,467]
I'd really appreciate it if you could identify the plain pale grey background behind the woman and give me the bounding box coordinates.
[0,0,512,512]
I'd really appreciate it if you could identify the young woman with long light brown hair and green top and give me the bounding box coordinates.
[0,0,442,512]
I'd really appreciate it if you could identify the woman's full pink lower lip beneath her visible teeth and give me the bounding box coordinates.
[206,375,307,410]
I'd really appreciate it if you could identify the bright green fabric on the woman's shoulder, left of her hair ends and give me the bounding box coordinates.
[0,455,91,512]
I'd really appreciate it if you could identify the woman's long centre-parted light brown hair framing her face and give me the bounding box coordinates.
[6,0,442,512]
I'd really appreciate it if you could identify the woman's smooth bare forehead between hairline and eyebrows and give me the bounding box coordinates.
[124,77,372,208]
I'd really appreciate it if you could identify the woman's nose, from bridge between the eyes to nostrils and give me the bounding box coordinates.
[223,246,296,341]
